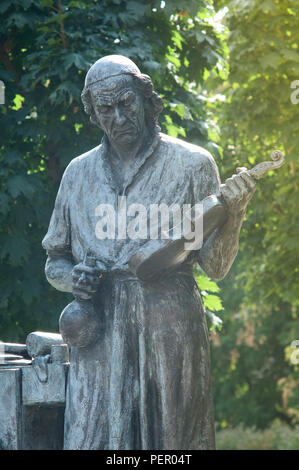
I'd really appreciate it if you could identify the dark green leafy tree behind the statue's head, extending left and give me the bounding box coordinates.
[0,0,221,341]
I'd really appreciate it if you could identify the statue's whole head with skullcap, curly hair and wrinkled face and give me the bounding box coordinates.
[81,55,163,145]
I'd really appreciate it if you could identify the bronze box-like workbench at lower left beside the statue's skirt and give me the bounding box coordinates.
[0,344,68,450]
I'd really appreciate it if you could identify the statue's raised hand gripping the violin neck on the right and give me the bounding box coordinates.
[220,171,256,217]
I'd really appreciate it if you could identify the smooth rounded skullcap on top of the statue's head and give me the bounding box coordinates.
[85,55,141,88]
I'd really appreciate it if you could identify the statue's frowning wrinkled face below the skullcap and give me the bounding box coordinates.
[90,75,145,147]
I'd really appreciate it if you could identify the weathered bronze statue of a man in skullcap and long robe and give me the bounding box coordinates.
[43,55,255,450]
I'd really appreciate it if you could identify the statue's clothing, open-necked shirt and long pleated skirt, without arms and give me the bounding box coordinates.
[43,133,220,450]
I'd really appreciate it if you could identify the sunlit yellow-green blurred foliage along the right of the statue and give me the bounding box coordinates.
[211,0,299,428]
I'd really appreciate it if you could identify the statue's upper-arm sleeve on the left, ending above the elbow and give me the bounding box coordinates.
[42,170,71,256]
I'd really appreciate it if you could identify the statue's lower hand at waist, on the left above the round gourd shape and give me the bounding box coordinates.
[72,263,101,299]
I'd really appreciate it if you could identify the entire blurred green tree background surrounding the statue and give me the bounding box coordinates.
[0,0,299,449]
